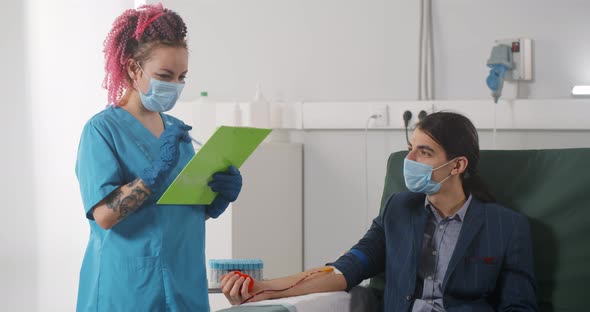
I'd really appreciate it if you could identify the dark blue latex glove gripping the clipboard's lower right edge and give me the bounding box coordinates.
[207,166,242,218]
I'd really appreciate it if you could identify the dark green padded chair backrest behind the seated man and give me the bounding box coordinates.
[371,148,590,311]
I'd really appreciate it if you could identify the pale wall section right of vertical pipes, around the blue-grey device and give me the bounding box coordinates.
[432,0,590,100]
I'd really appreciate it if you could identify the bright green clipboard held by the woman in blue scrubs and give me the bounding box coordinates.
[157,126,272,205]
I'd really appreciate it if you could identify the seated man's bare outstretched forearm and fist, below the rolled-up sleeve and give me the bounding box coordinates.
[221,266,347,305]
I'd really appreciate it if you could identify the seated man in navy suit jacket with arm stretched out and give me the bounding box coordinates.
[221,112,538,312]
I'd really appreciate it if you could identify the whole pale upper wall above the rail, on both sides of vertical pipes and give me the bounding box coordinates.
[162,0,590,101]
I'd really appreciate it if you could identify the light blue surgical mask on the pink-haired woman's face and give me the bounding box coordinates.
[137,64,184,112]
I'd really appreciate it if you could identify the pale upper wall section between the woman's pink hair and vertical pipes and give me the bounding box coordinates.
[155,0,418,101]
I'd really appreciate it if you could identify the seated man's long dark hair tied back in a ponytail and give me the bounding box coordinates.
[416,112,496,202]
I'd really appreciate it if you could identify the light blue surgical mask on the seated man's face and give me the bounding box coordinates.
[404,158,455,195]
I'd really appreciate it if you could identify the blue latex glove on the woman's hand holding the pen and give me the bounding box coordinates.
[139,125,192,190]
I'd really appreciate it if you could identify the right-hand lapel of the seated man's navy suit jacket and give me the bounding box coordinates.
[442,197,485,291]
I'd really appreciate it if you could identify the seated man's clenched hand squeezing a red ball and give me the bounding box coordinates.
[220,272,269,305]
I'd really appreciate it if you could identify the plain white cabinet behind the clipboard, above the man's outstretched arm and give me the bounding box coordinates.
[231,143,303,279]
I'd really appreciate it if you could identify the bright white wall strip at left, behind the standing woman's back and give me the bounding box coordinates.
[26,0,133,311]
